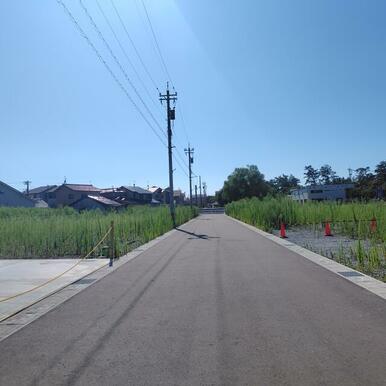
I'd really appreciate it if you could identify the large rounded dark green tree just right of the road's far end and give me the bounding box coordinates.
[218,165,269,202]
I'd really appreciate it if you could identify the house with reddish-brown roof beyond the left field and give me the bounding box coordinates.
[47,184,101,208]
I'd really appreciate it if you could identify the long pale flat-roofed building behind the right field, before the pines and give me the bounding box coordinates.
[291,184,354,202]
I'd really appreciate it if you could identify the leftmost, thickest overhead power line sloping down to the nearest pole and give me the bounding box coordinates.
[56,0,167,147]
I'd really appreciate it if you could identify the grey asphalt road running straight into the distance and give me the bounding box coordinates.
[0,215,386,386]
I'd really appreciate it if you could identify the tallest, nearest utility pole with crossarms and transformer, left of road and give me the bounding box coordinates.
[159,82,177,227]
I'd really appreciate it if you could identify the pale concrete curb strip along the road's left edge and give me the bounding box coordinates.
[0,217,197,342]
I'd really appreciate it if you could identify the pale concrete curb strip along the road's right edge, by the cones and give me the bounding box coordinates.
[225,215,386,300]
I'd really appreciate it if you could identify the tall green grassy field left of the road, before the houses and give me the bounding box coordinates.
[0,206,196,258]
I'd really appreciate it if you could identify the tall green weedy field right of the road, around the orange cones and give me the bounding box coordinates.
[226,198,386,281]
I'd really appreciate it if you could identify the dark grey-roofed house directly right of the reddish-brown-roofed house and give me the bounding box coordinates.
[101,186,153,205]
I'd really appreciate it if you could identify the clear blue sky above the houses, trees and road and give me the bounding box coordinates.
[0,0,386,193]
